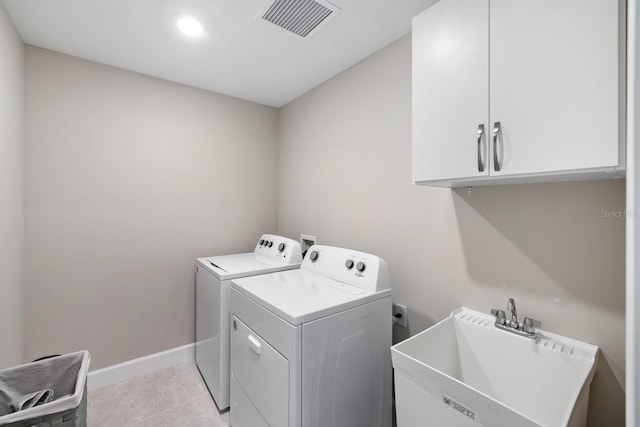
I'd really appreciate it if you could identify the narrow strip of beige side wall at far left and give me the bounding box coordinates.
[0,3,24,369]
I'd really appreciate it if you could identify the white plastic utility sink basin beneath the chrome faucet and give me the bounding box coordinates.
[391,307,598,427]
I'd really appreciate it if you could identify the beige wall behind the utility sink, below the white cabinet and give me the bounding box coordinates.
[278,36,625,426]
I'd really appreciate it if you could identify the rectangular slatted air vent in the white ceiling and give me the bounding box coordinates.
[257,0,340,38]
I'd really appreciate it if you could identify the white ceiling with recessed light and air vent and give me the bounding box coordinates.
[2,0,437,107]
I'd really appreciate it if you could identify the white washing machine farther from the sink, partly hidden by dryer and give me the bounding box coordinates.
[196,234,302,410]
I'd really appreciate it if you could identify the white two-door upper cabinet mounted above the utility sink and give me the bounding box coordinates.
[413,0,625,186]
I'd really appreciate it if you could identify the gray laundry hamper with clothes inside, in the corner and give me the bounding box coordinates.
[0,350,90,427]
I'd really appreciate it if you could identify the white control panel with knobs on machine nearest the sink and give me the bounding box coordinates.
[300,245,391,292]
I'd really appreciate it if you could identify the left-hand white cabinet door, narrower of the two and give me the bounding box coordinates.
[412,0,489,182]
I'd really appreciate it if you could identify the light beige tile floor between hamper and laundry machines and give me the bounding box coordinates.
[87,364,229,427]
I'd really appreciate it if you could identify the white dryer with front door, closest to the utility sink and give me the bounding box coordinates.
[230,245,393,427]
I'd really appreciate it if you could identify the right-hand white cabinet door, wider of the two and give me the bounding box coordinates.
[489,0,619,175]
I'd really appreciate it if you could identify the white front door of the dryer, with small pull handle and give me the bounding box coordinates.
[231,316,289,427]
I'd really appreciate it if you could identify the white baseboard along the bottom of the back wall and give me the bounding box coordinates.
[87,343,195,390]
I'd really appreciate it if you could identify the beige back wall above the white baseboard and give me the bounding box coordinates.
[25,46,277,369]
